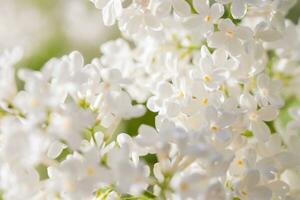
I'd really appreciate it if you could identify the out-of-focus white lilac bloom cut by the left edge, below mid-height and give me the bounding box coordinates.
[0,117,50,167]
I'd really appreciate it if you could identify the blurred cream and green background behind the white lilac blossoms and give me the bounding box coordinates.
[0,0,300,134]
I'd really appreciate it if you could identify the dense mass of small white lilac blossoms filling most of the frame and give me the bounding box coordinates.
[0,0,300,200]
